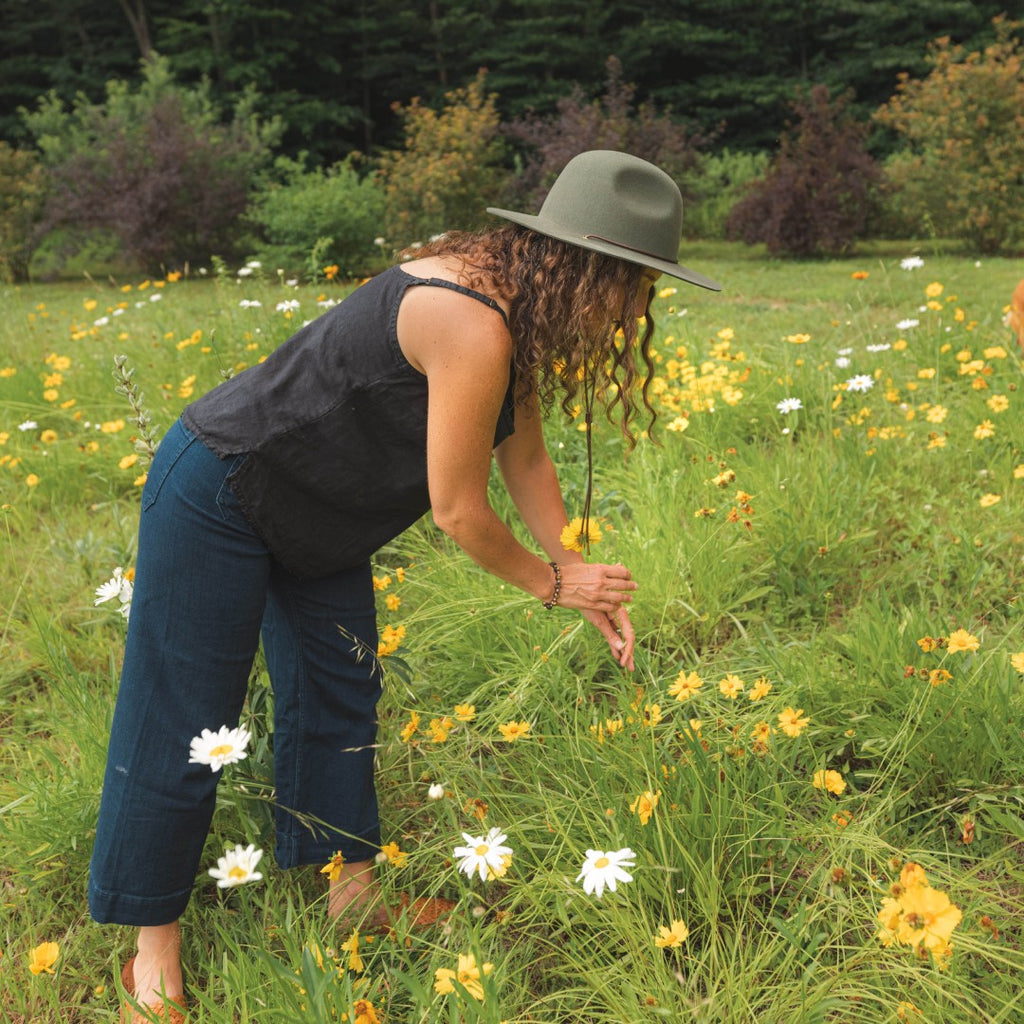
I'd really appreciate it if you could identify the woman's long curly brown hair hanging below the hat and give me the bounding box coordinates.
[401,224,657,447]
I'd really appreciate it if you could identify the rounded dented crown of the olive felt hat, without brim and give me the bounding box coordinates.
[540,150,683,262]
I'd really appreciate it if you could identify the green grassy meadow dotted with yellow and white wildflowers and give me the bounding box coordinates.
[0,246,1024,1024]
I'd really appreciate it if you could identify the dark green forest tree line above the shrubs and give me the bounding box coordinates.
[0,0,1005,166]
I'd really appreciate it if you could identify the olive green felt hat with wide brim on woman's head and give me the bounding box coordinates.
[487,150,722,292]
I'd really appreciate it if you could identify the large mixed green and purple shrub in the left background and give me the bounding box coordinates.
[23,56,280,271]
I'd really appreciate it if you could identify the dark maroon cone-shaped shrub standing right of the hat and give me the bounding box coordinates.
[727,85,881,256]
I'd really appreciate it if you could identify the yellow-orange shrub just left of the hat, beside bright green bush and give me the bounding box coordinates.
[380,71,507,247]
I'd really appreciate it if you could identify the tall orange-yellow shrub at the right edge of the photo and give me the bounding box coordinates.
[874,18,1024,253]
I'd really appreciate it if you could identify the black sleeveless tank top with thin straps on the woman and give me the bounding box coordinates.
[182,266,515,578]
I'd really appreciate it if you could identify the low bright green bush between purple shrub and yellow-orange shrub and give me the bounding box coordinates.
[249,157,384,275]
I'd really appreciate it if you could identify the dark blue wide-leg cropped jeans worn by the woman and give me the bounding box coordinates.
[89,422,381,925]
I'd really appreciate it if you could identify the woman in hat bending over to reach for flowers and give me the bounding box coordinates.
[89,152,719,1020]
